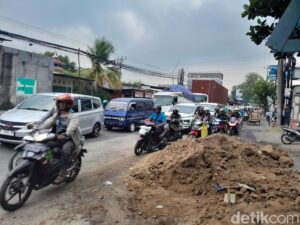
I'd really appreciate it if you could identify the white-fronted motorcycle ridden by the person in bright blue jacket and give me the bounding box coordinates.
[134,120,168,156]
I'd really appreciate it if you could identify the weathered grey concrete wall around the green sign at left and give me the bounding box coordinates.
[0,45,54,109]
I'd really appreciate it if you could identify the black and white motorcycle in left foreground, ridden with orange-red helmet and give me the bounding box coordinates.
[0,129,87,211]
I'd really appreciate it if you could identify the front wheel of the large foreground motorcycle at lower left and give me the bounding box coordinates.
[0,174,32,211]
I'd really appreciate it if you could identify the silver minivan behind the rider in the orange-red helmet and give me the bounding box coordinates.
[0,93,104,144]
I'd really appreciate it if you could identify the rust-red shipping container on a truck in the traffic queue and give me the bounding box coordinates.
[192,80,228,105]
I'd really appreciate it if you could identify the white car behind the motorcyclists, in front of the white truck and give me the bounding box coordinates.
[166,103,200,130]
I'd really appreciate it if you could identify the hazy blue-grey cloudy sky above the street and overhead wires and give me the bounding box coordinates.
[0,0,299,89]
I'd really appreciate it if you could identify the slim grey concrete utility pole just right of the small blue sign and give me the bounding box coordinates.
[277,59,285,125]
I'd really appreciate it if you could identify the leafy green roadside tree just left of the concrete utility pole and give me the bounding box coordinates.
[253,79,276,112]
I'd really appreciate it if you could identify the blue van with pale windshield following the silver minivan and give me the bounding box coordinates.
[104,98,154,132]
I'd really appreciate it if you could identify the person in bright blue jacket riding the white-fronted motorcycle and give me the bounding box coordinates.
[149,105,167,143]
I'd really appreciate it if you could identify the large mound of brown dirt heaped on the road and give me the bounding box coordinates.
[128,135,300,224]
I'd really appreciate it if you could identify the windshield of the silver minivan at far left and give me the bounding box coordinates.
[18,95,55,111]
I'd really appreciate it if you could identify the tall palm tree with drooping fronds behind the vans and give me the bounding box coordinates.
[88,37,122,88]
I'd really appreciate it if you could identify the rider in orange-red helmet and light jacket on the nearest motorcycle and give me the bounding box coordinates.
[39,94,81,183]
